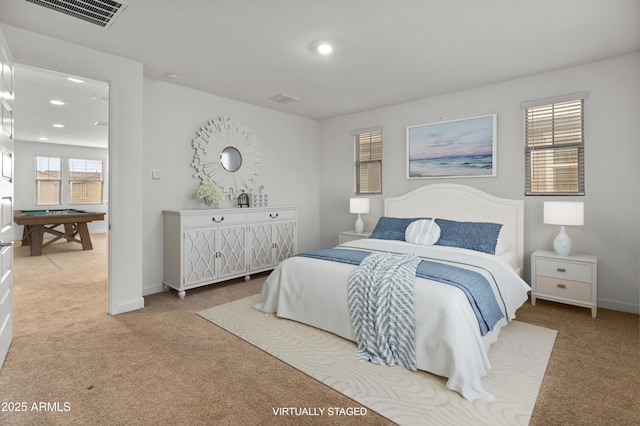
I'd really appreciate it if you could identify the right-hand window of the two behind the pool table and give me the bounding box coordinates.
[69,158,102,204]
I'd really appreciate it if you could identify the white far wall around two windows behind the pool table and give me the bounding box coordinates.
[13,143,109,236]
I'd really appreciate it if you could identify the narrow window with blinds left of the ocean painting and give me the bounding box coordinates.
[355,128,382,194]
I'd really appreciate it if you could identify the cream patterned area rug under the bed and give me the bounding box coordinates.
[198,295,556,425]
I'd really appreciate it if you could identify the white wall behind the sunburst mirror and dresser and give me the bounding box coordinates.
[142,80,320,295]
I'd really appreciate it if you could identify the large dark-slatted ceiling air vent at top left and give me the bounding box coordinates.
[27,0,129,28]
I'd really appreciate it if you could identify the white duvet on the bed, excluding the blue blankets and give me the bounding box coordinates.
[254,239,531,401]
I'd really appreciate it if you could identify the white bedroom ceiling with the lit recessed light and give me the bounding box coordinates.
[0,0,640,148]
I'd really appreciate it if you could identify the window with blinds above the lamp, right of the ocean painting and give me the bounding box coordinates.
[522,94,586,195]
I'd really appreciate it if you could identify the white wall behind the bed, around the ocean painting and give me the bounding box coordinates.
[320,53,640,313]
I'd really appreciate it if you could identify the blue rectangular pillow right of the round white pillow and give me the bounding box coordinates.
[436,219,502,254]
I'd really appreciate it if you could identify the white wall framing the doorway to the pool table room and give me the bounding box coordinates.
[2,25,144,314]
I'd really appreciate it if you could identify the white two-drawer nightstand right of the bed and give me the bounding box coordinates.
[531,250,598,318]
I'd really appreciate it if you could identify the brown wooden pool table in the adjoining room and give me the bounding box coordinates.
[13,209,106,256]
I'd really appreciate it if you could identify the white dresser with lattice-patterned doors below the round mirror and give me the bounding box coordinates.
[162,207,297,299]
